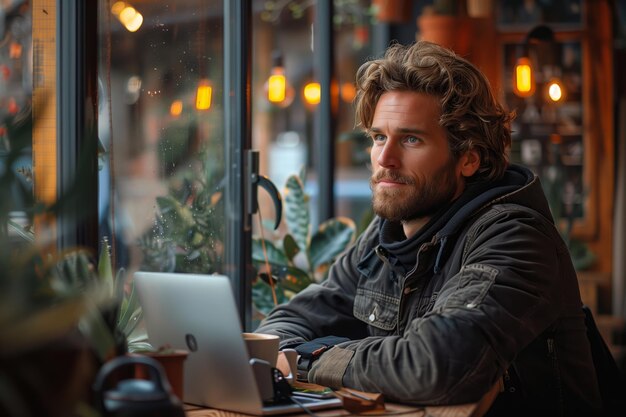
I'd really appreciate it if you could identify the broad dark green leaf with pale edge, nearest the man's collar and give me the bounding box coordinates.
[309,217,356,269]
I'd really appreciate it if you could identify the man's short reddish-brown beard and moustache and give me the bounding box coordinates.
[370,158,458,222]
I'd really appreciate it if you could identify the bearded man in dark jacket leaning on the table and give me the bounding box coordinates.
[257,41,600,416]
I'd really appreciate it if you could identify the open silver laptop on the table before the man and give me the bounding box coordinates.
[134,271,342,415]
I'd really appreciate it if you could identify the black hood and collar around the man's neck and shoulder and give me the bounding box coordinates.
[379,165,552,273]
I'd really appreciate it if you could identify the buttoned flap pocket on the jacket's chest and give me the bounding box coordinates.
[353,288,400,331]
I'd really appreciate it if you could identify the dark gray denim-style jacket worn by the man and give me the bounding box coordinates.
[257,166,600,415]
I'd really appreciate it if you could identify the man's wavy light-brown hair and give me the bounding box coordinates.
[355,41,514,180]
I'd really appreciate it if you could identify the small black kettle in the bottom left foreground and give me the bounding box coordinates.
[93,355,185,417]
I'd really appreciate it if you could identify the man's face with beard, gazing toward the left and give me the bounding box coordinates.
[370,91,464,221]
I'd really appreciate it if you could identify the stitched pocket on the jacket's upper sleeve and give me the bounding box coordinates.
[440,264,498,308]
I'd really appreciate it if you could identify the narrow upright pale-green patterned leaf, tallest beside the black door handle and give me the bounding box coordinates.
[284,175,311,253]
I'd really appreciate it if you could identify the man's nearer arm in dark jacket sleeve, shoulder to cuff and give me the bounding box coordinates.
[309,211,564,404]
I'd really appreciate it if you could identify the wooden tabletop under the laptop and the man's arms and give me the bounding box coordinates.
[185,382,501,417]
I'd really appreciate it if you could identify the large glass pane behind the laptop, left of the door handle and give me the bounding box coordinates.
[99,0,226,273]
